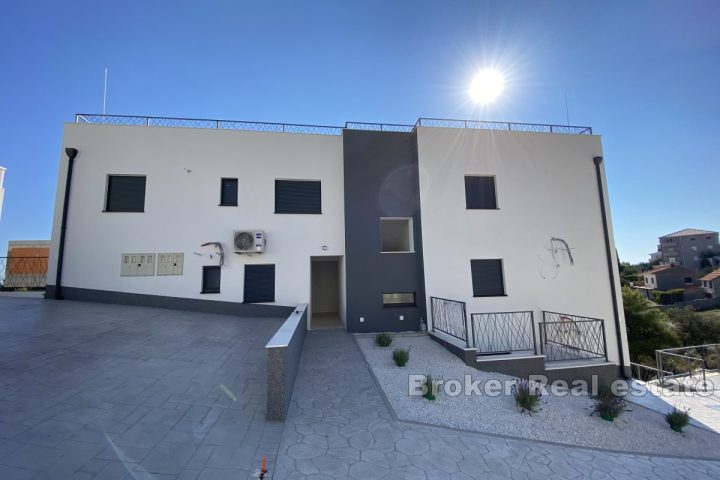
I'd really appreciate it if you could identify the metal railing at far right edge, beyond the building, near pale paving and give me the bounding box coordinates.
[655,343,720,391]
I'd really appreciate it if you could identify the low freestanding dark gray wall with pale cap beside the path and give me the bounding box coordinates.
[265,305,307,421]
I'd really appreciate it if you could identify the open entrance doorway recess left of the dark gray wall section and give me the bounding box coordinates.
[310,257,345,330]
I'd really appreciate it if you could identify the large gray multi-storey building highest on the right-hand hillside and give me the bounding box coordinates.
[651,228,720,270]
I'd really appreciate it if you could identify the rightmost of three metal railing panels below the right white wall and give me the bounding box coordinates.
[539,311,607,362]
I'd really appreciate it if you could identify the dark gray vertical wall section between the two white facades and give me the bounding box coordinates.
[343,130,427,332]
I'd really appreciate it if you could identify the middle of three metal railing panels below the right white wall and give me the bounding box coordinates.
[470,311,537,355]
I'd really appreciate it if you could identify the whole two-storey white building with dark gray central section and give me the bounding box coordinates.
[47,115,629,380]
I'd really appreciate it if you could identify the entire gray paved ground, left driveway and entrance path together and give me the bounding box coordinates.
[0,297,720,480]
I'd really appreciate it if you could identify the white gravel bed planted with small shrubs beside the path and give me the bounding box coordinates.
[356,335,720,458]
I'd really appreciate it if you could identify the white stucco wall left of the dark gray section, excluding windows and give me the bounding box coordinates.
[48,124,345,306]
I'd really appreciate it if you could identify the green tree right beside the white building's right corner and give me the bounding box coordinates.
[622,287,681,365]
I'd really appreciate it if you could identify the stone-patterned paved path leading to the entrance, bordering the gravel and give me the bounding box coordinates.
[274,331,720,480]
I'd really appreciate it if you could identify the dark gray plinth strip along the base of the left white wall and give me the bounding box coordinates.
[45,285,294,317]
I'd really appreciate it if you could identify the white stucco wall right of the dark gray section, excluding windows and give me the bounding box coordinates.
[418,127,628,362]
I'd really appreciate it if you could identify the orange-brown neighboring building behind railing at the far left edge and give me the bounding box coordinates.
[0,240,50,289]
